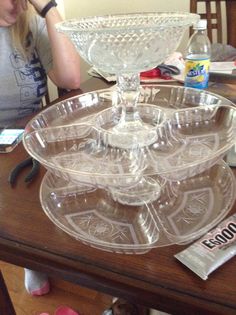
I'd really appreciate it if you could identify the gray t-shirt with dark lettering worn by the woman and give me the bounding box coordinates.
[0,16,52,127]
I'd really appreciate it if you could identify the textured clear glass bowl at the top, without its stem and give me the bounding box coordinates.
[56,12,199,74]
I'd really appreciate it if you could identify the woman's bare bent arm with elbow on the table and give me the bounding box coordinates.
[24,0,80,89]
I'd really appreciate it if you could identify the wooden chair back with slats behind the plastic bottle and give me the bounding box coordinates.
[190,0,236,47]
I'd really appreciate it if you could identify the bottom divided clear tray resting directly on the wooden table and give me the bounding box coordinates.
[40,161,236,254]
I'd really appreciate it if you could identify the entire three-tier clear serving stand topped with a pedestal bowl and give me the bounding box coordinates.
[23,13,235,254]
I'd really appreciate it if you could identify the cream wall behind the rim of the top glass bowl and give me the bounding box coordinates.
[61,0,189,82]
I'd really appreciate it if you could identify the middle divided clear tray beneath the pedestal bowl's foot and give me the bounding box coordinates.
[23,85,235,189]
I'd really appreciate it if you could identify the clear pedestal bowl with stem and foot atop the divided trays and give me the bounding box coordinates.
[56,12,199,149]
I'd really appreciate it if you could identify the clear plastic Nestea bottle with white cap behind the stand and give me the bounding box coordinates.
[184,20,211,89]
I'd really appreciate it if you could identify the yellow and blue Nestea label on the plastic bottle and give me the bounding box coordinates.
[184,59,210,89]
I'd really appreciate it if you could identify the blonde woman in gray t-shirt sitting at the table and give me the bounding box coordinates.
[0,0,80,295]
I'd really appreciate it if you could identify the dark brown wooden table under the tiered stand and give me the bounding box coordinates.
[0,80,236,315]
